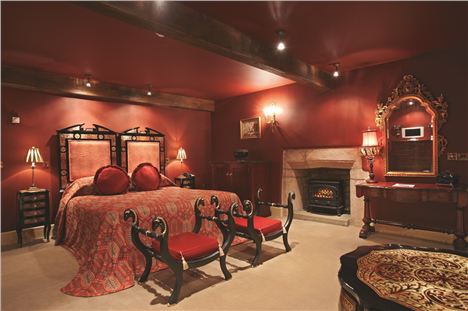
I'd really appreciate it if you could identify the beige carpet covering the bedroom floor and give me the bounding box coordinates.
[1,220,449,311]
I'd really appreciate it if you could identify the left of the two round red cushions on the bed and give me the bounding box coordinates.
[94,165,130,194]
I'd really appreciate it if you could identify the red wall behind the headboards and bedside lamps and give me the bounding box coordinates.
[1,87,211,231]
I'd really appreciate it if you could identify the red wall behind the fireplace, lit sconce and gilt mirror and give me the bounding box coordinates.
[212,47,468,229]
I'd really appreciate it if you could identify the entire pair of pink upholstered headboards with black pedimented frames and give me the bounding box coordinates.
[57,123,166,190]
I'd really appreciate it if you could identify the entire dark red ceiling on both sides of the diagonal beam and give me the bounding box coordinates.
[1,1,468,99]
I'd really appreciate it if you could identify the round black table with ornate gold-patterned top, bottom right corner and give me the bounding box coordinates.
[338,245,468,311]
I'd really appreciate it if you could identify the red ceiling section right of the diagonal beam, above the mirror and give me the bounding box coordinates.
[185,1,468,70]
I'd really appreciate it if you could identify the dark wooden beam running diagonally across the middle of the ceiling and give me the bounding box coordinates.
[79,1,333,91]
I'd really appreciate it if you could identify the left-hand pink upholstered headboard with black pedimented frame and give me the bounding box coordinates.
[57,123,118,190]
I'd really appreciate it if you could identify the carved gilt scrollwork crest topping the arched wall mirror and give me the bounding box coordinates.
[375,75,448,129]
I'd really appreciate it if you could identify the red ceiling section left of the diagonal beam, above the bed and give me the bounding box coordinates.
[1,2,293,99]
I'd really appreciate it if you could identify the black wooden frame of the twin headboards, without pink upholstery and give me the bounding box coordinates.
[57,123,166,192]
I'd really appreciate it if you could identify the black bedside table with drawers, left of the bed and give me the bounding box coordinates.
[16,188,50,247]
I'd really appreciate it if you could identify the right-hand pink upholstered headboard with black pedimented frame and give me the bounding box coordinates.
[119,127,166,174]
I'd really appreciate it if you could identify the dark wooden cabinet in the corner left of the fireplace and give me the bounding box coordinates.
[211,161,271,216]
